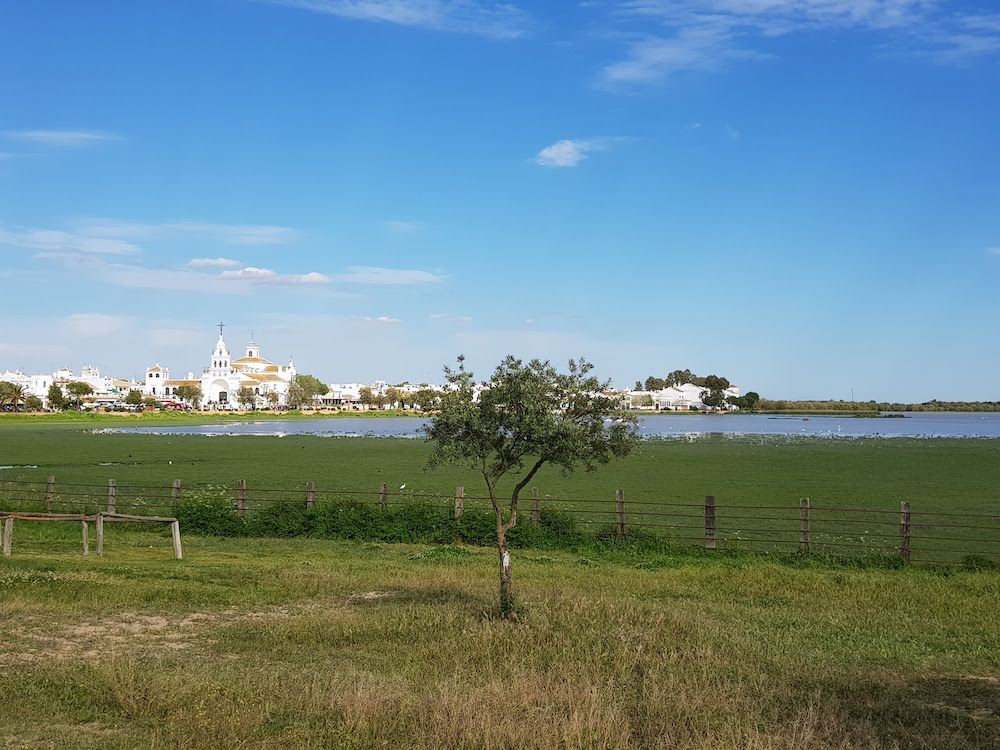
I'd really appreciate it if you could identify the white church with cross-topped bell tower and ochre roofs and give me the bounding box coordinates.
[143,323,295,409]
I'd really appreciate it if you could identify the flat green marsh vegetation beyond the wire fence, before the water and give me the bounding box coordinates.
[0,421,1000,561]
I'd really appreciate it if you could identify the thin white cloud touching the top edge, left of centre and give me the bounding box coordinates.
[266,0,531,40]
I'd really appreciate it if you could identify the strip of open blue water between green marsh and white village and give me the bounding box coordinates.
[103,412,1000,438]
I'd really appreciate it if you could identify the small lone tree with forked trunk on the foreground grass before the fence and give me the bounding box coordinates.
[424,356,638,617]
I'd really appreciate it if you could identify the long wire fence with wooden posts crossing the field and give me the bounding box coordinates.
[0,477,1000,567]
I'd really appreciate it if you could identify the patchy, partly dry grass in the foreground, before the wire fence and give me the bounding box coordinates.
[0,525,1000,750]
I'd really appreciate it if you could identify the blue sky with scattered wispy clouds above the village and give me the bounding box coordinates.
[0,0,1000,400]
